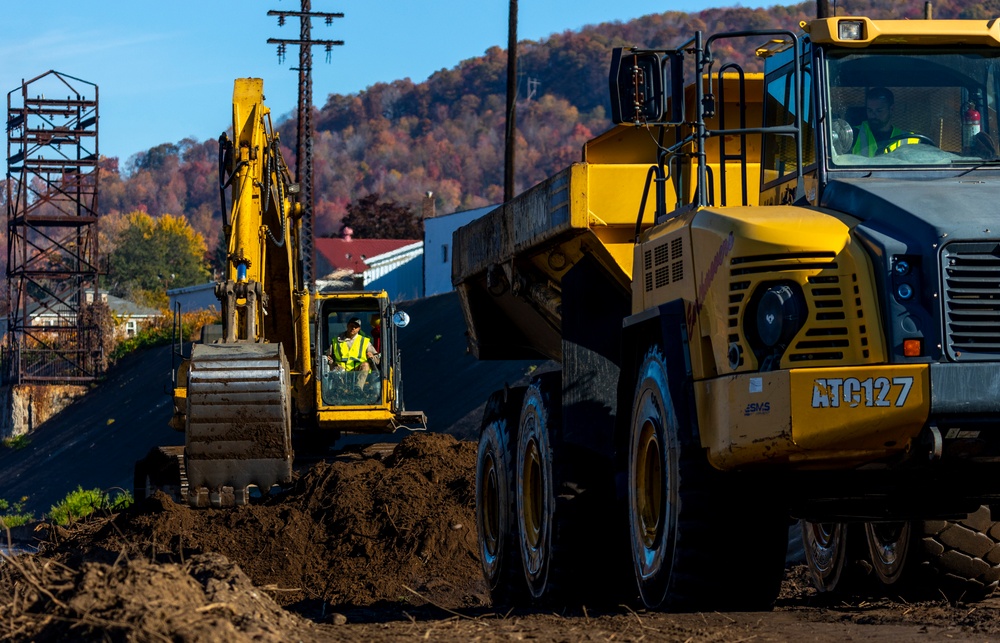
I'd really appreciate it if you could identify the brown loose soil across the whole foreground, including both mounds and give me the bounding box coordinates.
[0,434,1000,642]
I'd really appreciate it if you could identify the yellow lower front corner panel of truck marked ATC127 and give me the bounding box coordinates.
[695,364,931,470]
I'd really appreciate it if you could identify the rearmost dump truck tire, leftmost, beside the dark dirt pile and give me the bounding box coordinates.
[476,418,527,606]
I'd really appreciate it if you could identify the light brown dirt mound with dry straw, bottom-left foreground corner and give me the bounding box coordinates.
[0,554,322,642]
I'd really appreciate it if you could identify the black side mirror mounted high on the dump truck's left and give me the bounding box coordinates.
[608,47,664,124]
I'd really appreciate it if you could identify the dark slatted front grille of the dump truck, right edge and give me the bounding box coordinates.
[941,241,1000,361]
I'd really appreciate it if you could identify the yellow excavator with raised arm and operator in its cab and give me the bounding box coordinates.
[135,78,426,507]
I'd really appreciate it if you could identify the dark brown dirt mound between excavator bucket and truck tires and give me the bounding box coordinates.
[31,434,488,614]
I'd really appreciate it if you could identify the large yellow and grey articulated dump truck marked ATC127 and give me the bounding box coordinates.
[453,17,1000,609]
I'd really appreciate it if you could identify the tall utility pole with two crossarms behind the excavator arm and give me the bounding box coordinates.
[267,0,344,293]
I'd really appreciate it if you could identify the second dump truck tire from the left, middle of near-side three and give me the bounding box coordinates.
[515,378,572,603]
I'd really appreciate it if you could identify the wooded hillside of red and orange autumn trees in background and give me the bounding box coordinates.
[92,0,1000,270]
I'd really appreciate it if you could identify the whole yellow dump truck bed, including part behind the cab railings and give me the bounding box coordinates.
[452,74,763,361]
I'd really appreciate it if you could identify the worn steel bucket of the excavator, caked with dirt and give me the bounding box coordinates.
[185,344,292,507]
